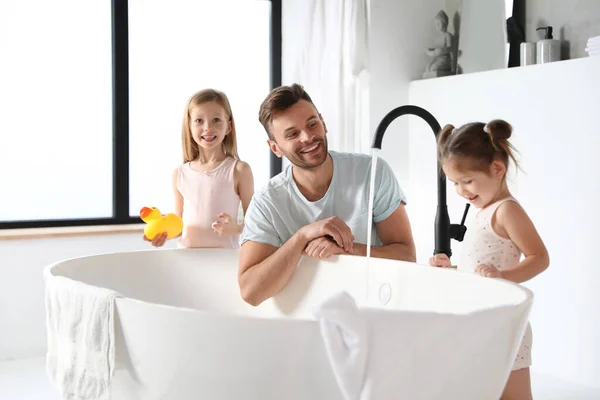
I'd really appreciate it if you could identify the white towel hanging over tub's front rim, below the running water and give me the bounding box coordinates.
[313,292,369,400]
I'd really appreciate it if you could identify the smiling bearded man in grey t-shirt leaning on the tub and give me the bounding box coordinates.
[238,84,415,306]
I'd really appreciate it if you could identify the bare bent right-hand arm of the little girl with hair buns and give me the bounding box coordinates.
[492,201,550,283]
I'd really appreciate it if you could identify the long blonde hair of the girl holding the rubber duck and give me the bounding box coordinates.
[181,89,240,163]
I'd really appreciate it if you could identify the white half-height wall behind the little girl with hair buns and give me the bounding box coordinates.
[408,57,600,388]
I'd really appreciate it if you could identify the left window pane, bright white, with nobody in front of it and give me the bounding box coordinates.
[0,0,112,222]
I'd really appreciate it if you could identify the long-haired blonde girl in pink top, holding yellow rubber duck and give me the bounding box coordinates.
[145,89,254,248]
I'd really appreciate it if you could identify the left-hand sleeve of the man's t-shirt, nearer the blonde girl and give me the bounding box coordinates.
[240,195,283,247]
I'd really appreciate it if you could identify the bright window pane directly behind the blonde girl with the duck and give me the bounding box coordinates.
[129,0,271,216]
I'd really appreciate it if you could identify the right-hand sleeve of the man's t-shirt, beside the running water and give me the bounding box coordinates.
[373,158,406,223]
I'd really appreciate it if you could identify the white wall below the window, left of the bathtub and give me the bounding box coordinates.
[0,233,175,362]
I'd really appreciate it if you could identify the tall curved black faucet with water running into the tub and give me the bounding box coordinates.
[371,105,470,257]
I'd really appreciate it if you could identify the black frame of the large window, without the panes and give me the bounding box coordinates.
[0,0,282,230]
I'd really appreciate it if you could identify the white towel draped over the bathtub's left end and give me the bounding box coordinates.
[45,272,118,400]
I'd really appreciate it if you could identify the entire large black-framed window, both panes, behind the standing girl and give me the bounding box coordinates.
[0,0,281,229]
